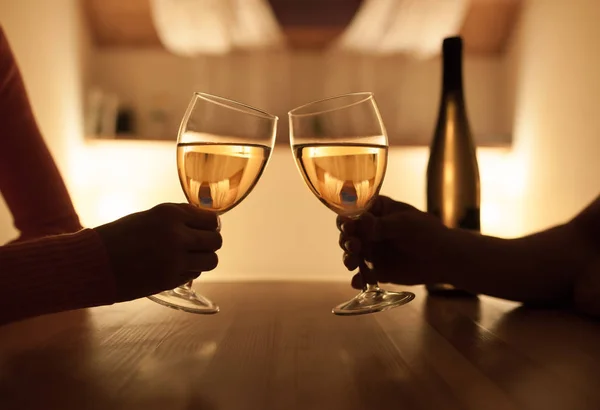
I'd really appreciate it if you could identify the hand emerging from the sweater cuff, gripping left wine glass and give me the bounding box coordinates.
[94,204,222,302]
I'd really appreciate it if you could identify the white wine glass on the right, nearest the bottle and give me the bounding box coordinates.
[288,92,415,315]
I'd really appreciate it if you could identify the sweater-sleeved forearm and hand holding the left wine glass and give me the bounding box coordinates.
[0,204,222,325]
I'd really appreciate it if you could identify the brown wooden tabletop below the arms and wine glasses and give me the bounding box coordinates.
[0,283,600,410]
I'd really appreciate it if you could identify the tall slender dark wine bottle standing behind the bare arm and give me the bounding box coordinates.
[427,37,480,295]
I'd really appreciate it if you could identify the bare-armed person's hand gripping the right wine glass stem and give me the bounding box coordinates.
[337,196,461,289]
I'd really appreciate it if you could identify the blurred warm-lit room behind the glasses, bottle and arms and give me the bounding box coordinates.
[0,0,600,281]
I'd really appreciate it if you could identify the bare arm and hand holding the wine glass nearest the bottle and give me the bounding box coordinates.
[338,197,600,315]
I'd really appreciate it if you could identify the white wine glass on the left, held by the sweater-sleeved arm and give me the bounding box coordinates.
[149,93,278,314]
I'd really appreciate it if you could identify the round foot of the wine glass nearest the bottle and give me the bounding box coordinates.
[332,288,415,316]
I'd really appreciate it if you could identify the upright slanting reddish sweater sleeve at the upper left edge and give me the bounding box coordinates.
[0,27,81,240]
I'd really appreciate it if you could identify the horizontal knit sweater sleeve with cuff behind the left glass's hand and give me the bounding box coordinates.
[0,229,116,324]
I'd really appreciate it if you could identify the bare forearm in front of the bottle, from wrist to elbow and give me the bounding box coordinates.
[446,224,594,304]
